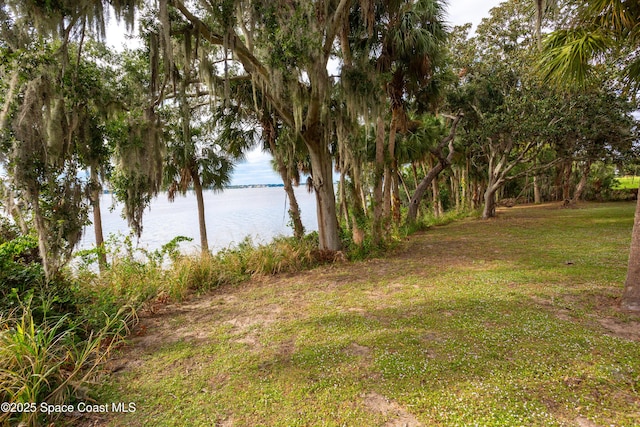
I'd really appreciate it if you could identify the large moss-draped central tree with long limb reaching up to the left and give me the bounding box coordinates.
[159,0,350,250]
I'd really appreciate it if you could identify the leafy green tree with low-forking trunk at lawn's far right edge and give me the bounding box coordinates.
[449,0,551,219]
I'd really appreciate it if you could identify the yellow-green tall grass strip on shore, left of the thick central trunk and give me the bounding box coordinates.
[78,235,321,313]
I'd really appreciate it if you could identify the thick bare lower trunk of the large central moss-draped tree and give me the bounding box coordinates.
[306,141,342,251]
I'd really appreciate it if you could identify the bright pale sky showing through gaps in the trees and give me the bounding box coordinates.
[107,0,501,185]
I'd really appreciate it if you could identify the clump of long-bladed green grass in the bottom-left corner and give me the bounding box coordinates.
[0,302,134,426]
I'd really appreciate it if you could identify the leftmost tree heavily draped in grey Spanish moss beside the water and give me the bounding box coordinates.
[0,0,169,279]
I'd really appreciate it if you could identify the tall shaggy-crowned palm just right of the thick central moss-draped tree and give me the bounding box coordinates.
[340,0,447,234]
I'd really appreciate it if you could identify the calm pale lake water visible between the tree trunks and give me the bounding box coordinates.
[80,186,318,252]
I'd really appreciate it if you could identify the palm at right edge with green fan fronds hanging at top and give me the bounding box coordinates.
[537,0,640,311]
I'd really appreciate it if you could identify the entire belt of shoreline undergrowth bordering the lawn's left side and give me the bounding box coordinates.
[0,206,467,425]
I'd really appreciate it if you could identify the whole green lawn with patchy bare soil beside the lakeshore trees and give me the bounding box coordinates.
[87,202,640,426]
